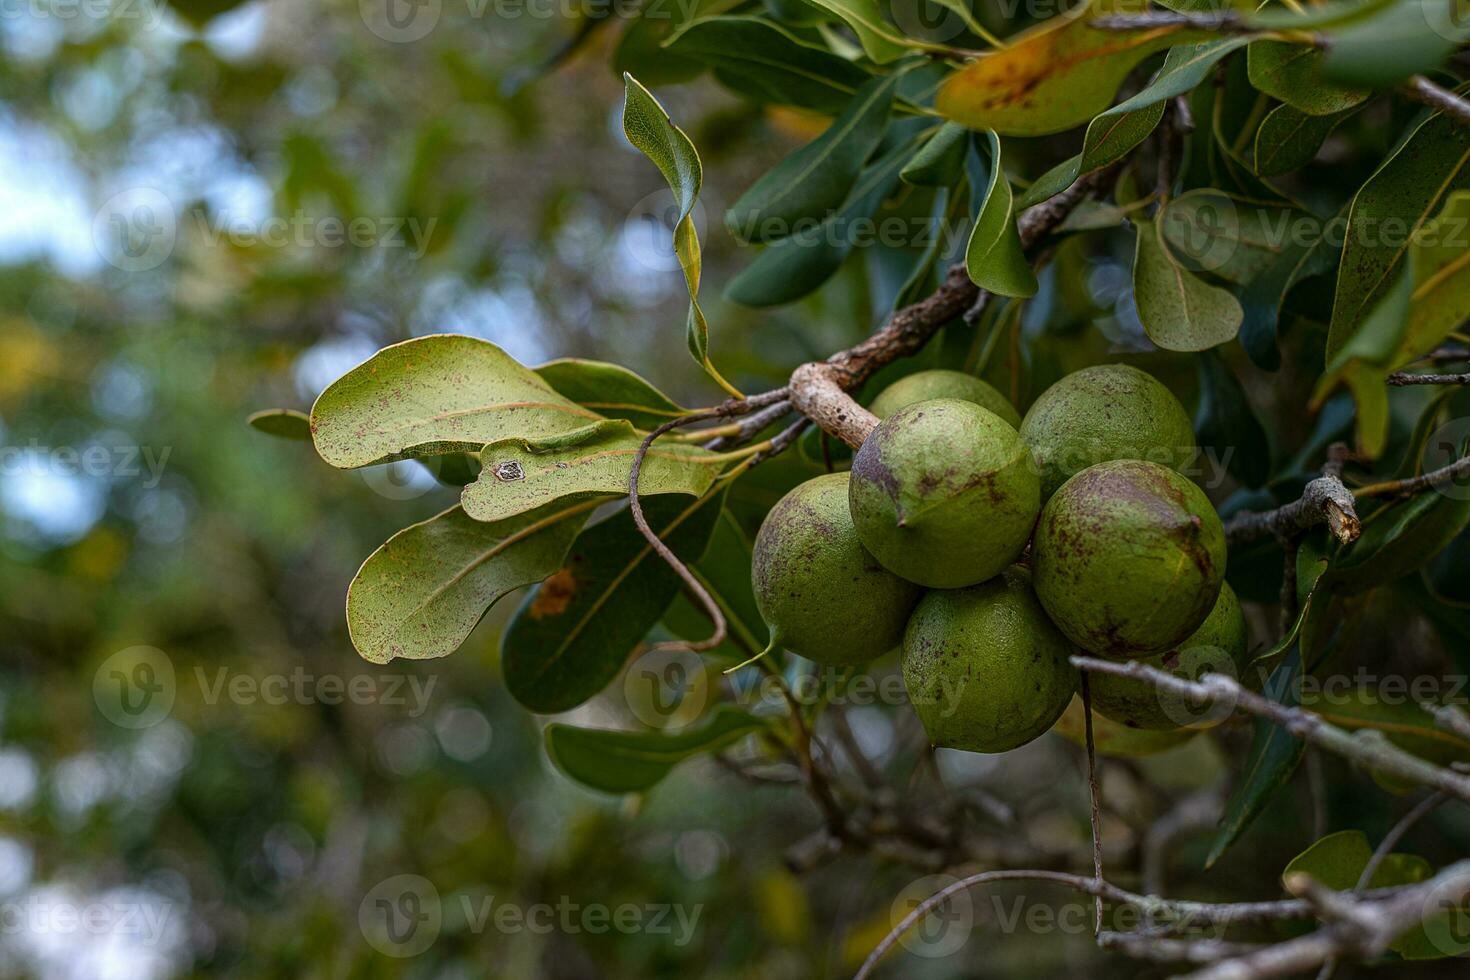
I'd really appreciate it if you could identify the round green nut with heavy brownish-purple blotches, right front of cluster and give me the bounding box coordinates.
[1032,460,1226,660]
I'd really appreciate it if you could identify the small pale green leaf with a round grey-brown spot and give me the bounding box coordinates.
[460,419,725,520]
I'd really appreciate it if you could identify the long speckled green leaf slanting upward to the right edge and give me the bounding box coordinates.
[1327,85,1470,363]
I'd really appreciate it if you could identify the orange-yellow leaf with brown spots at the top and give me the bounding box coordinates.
[935,0,1191,137]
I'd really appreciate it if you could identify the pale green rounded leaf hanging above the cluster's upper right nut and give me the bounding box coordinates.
[1133,219,1244,351]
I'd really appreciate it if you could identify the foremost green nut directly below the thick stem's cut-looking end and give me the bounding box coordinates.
[848,398,1041,589]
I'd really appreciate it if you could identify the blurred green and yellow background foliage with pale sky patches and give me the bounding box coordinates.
[0,0,1470,980]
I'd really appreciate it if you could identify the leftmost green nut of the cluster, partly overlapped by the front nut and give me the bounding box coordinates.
[751,473,923,664]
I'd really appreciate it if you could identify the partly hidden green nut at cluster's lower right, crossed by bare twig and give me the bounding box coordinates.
[1088,585,1247,732]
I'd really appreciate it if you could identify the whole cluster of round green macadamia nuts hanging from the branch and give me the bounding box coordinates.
[753,364,1247,752]
